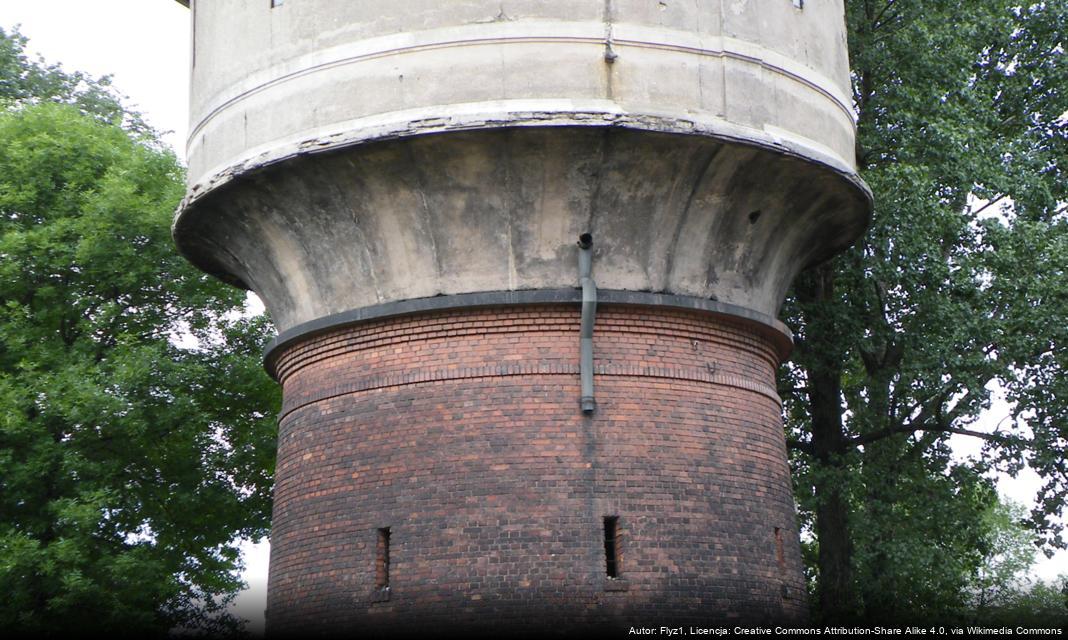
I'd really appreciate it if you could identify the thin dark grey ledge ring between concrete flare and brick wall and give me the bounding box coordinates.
[264,288,794,378]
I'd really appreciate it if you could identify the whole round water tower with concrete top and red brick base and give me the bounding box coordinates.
[168,0,870,634]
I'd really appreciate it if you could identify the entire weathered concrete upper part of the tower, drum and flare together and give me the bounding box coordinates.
[175,0,870,330]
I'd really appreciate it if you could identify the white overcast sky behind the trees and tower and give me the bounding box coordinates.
[0,0,1068,625]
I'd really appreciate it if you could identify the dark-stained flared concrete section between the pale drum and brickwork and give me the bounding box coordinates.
[170,127,867,330]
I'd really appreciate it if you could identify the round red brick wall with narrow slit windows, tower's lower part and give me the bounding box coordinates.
[267,306,805,633]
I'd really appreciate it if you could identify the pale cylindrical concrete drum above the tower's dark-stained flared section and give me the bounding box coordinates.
[179,0,853,205]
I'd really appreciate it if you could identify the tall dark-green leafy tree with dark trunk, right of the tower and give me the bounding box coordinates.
[781,0,1068,620]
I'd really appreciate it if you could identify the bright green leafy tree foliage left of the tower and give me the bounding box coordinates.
[0,27,278,636]
